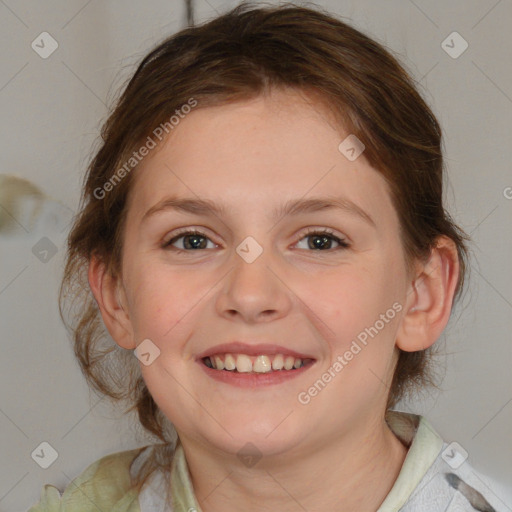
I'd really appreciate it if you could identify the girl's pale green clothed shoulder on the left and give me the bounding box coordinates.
[28,446,148,512]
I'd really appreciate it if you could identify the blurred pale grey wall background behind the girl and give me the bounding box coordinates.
[0,0,512,511]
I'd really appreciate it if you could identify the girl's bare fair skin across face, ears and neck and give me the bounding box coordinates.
[89,91,458,512]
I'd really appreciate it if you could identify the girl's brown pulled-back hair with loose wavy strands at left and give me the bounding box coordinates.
[59,3,469,496]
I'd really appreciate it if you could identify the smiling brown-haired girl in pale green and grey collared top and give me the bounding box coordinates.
[31,4,503,512]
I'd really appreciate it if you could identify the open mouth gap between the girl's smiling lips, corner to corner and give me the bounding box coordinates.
[201,353,314,374]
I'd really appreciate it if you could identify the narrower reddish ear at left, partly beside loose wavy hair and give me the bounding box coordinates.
[88,256,136,349]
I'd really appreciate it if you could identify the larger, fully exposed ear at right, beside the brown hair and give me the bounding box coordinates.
[396,236,459,352]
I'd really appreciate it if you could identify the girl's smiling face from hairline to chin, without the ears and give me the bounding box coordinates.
[117,88,407,455]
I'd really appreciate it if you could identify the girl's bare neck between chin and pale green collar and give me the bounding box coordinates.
[176,412,407,512]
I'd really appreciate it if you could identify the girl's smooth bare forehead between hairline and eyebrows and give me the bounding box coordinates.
[126,91,392,226]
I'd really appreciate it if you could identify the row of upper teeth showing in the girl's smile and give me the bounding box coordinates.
[206,354,304,373]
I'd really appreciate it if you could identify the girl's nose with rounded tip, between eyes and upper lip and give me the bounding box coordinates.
[216,243,293,323]
